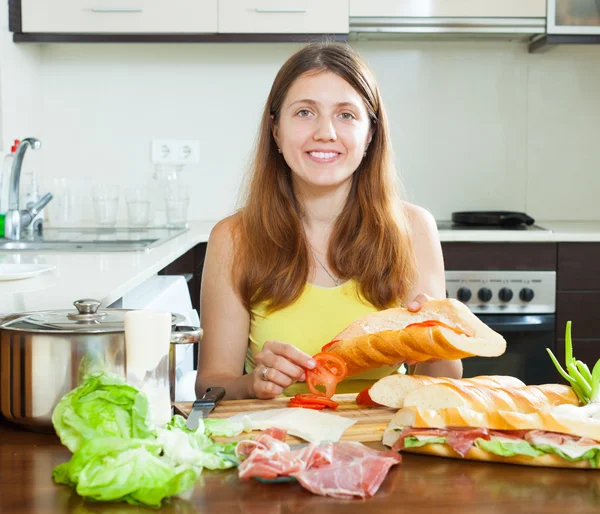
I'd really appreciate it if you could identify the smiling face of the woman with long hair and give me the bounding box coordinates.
[273,71,372,192]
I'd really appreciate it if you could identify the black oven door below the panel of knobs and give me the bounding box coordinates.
[462,314,562,385]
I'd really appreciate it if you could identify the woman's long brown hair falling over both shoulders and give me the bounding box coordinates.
[233,43,416,311]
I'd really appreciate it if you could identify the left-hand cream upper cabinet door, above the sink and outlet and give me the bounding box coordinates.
[21,0,218,34]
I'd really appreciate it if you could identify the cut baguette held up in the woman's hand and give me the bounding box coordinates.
[322,298,506,376]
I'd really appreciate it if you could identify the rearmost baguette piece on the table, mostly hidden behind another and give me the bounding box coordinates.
[369,373,525,409]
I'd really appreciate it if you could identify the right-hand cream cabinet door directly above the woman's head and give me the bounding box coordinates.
[219,0,349,34]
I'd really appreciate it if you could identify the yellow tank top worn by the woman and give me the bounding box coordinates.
[245,280,404,396]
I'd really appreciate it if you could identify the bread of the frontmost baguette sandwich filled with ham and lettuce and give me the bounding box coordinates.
[382,406,600,469]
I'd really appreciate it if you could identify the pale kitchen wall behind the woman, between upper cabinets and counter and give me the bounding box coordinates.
[0,9,600,222]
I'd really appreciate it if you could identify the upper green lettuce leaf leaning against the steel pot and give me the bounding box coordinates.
[52,373,155,452]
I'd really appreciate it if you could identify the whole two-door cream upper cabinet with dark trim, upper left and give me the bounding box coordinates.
[8,0,349,43]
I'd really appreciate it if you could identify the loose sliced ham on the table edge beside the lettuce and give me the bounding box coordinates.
[237,431,401,498]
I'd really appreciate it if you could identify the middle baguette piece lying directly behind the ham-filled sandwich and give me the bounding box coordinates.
[400,381,579,414]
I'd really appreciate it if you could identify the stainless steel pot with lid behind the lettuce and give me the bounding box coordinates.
[0,299,202,432]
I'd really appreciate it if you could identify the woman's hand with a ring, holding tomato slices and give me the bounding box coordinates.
[251,341,316,400]
